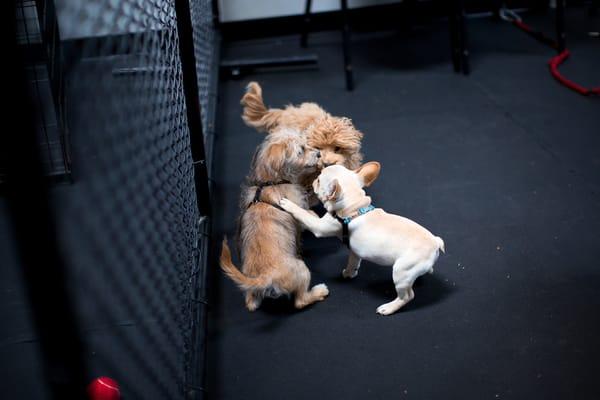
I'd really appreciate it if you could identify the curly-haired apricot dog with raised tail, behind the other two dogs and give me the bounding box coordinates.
[241,82,363,170]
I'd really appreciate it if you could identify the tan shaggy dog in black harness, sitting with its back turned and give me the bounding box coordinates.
[220,128,329,311]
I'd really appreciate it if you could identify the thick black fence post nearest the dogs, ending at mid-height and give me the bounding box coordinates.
[175,0,211,216]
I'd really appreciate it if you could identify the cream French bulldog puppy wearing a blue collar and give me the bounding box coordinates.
[279,162,445,315]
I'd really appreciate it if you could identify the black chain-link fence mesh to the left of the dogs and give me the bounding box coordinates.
[5,0,218,399]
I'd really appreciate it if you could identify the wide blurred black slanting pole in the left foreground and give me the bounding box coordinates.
[0,1,87,399]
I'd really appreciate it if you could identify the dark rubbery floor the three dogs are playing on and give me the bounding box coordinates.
[208,10,600,400]
